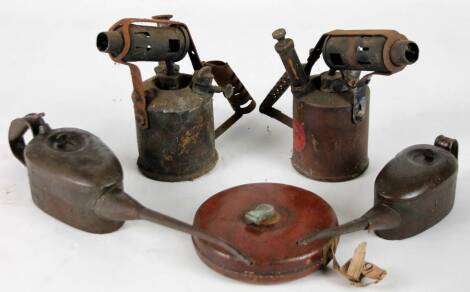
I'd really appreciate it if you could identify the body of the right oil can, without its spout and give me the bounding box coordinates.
[374,144,458,239]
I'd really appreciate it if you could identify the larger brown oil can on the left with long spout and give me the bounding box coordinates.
[8,114,250,264]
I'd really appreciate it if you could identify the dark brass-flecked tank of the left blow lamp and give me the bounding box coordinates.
[134,74,217,181]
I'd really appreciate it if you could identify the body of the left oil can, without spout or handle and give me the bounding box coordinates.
[24,128,124,233]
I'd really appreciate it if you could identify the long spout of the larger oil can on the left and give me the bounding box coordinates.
[94,188,252,265]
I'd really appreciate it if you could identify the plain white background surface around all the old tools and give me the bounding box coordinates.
[0,0,470,292]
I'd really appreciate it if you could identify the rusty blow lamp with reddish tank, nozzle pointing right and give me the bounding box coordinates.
[260,29,419,181]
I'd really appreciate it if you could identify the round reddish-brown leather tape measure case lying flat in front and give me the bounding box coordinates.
[193,183,337,283]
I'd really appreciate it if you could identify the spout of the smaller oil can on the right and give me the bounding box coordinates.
[297,205,401,245]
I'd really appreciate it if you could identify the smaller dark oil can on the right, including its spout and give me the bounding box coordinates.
[299,135,459,245]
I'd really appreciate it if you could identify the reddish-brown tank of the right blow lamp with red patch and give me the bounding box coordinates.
[292,76,369,181]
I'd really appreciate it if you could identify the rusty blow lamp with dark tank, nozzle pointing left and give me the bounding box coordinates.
[97,15,256,181]
